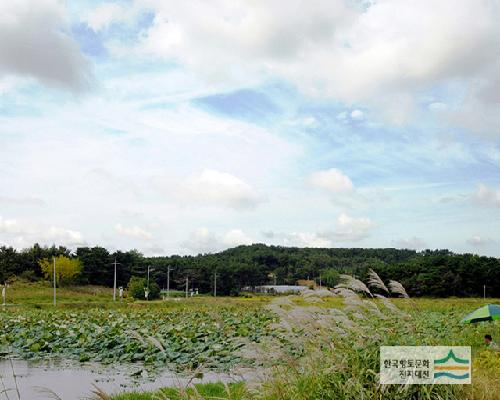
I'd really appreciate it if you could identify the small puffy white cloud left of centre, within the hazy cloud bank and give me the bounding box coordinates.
[181,169,262,210]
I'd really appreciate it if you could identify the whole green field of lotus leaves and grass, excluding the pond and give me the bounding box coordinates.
[0,284,500,400]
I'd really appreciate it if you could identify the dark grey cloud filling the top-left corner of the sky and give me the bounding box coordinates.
[0,0,92,91]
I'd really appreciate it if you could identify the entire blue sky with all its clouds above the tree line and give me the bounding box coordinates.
[0,0,500,256]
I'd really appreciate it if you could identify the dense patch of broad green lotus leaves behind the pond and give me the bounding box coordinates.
[0,303,273,369]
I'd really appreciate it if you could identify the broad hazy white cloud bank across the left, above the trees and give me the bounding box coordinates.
[0,92,299,254]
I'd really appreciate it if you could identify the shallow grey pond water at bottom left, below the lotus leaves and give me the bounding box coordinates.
[0,359,250,400]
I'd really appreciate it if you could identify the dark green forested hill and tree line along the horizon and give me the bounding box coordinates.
[0,244,500,297]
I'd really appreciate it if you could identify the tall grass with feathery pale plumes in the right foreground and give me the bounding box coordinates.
[252,282,500,400]
